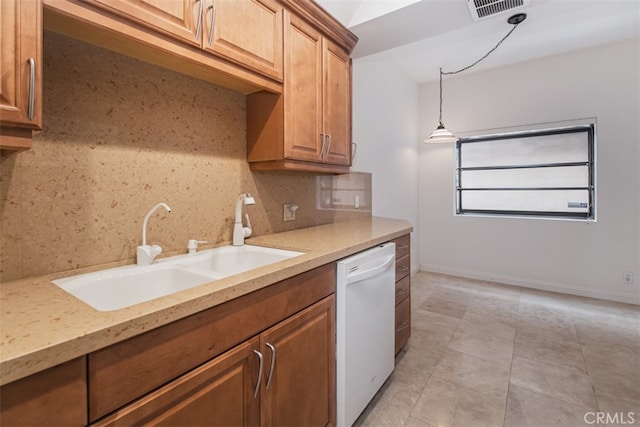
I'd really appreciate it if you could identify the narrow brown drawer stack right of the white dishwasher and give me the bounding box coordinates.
[393,234,411,354]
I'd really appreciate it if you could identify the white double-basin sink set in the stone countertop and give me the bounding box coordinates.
[53,245,303,311]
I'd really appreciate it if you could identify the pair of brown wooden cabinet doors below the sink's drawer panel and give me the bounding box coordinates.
[95,295,335,426]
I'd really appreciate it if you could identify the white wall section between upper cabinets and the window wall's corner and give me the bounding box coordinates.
[352,59,419,269]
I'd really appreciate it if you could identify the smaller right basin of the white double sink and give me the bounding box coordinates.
[175,245,304,277]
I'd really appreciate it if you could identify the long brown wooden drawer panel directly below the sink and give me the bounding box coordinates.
[89,264,336,421]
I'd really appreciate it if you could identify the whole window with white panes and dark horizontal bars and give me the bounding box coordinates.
[456,124,595,220]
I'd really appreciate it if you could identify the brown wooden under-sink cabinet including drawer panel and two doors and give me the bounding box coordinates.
[88,264,335,425]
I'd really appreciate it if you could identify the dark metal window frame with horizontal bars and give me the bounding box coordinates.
[454,122,596,221]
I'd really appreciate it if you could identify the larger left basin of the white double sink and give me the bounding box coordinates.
[53,265,220,311]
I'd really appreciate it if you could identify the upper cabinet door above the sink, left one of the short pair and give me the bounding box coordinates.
[84,0,200,46]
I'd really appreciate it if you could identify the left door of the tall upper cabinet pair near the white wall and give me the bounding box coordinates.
[284,14,326,162]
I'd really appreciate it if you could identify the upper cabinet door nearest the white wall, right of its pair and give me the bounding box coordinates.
[323,39,351,166]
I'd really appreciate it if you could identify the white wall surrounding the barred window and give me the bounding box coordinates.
[418,39,640,303]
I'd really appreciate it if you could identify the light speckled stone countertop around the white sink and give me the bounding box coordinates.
[0,217,413,385]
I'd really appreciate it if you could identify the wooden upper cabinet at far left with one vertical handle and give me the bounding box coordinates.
[0,0,42,150]
